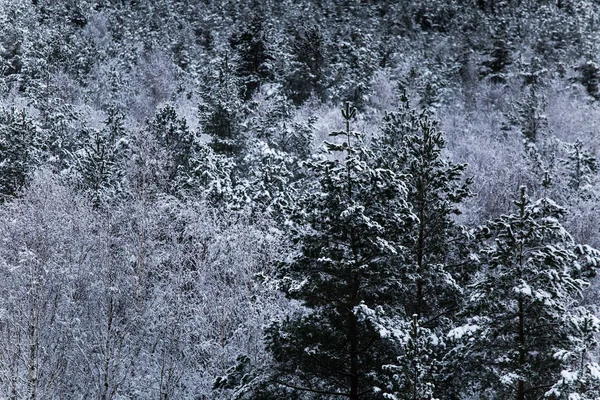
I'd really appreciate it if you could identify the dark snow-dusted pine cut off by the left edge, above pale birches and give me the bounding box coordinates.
[0,109,36,203]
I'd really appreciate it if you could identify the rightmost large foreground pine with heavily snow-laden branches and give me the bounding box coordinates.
[450,188,599,400]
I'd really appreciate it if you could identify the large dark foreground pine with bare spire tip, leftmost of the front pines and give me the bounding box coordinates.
[257,103,414,400]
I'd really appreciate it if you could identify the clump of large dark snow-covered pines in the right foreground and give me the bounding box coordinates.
[217,103,600,399]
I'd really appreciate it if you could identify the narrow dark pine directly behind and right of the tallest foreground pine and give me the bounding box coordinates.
[375,95,470,328]
